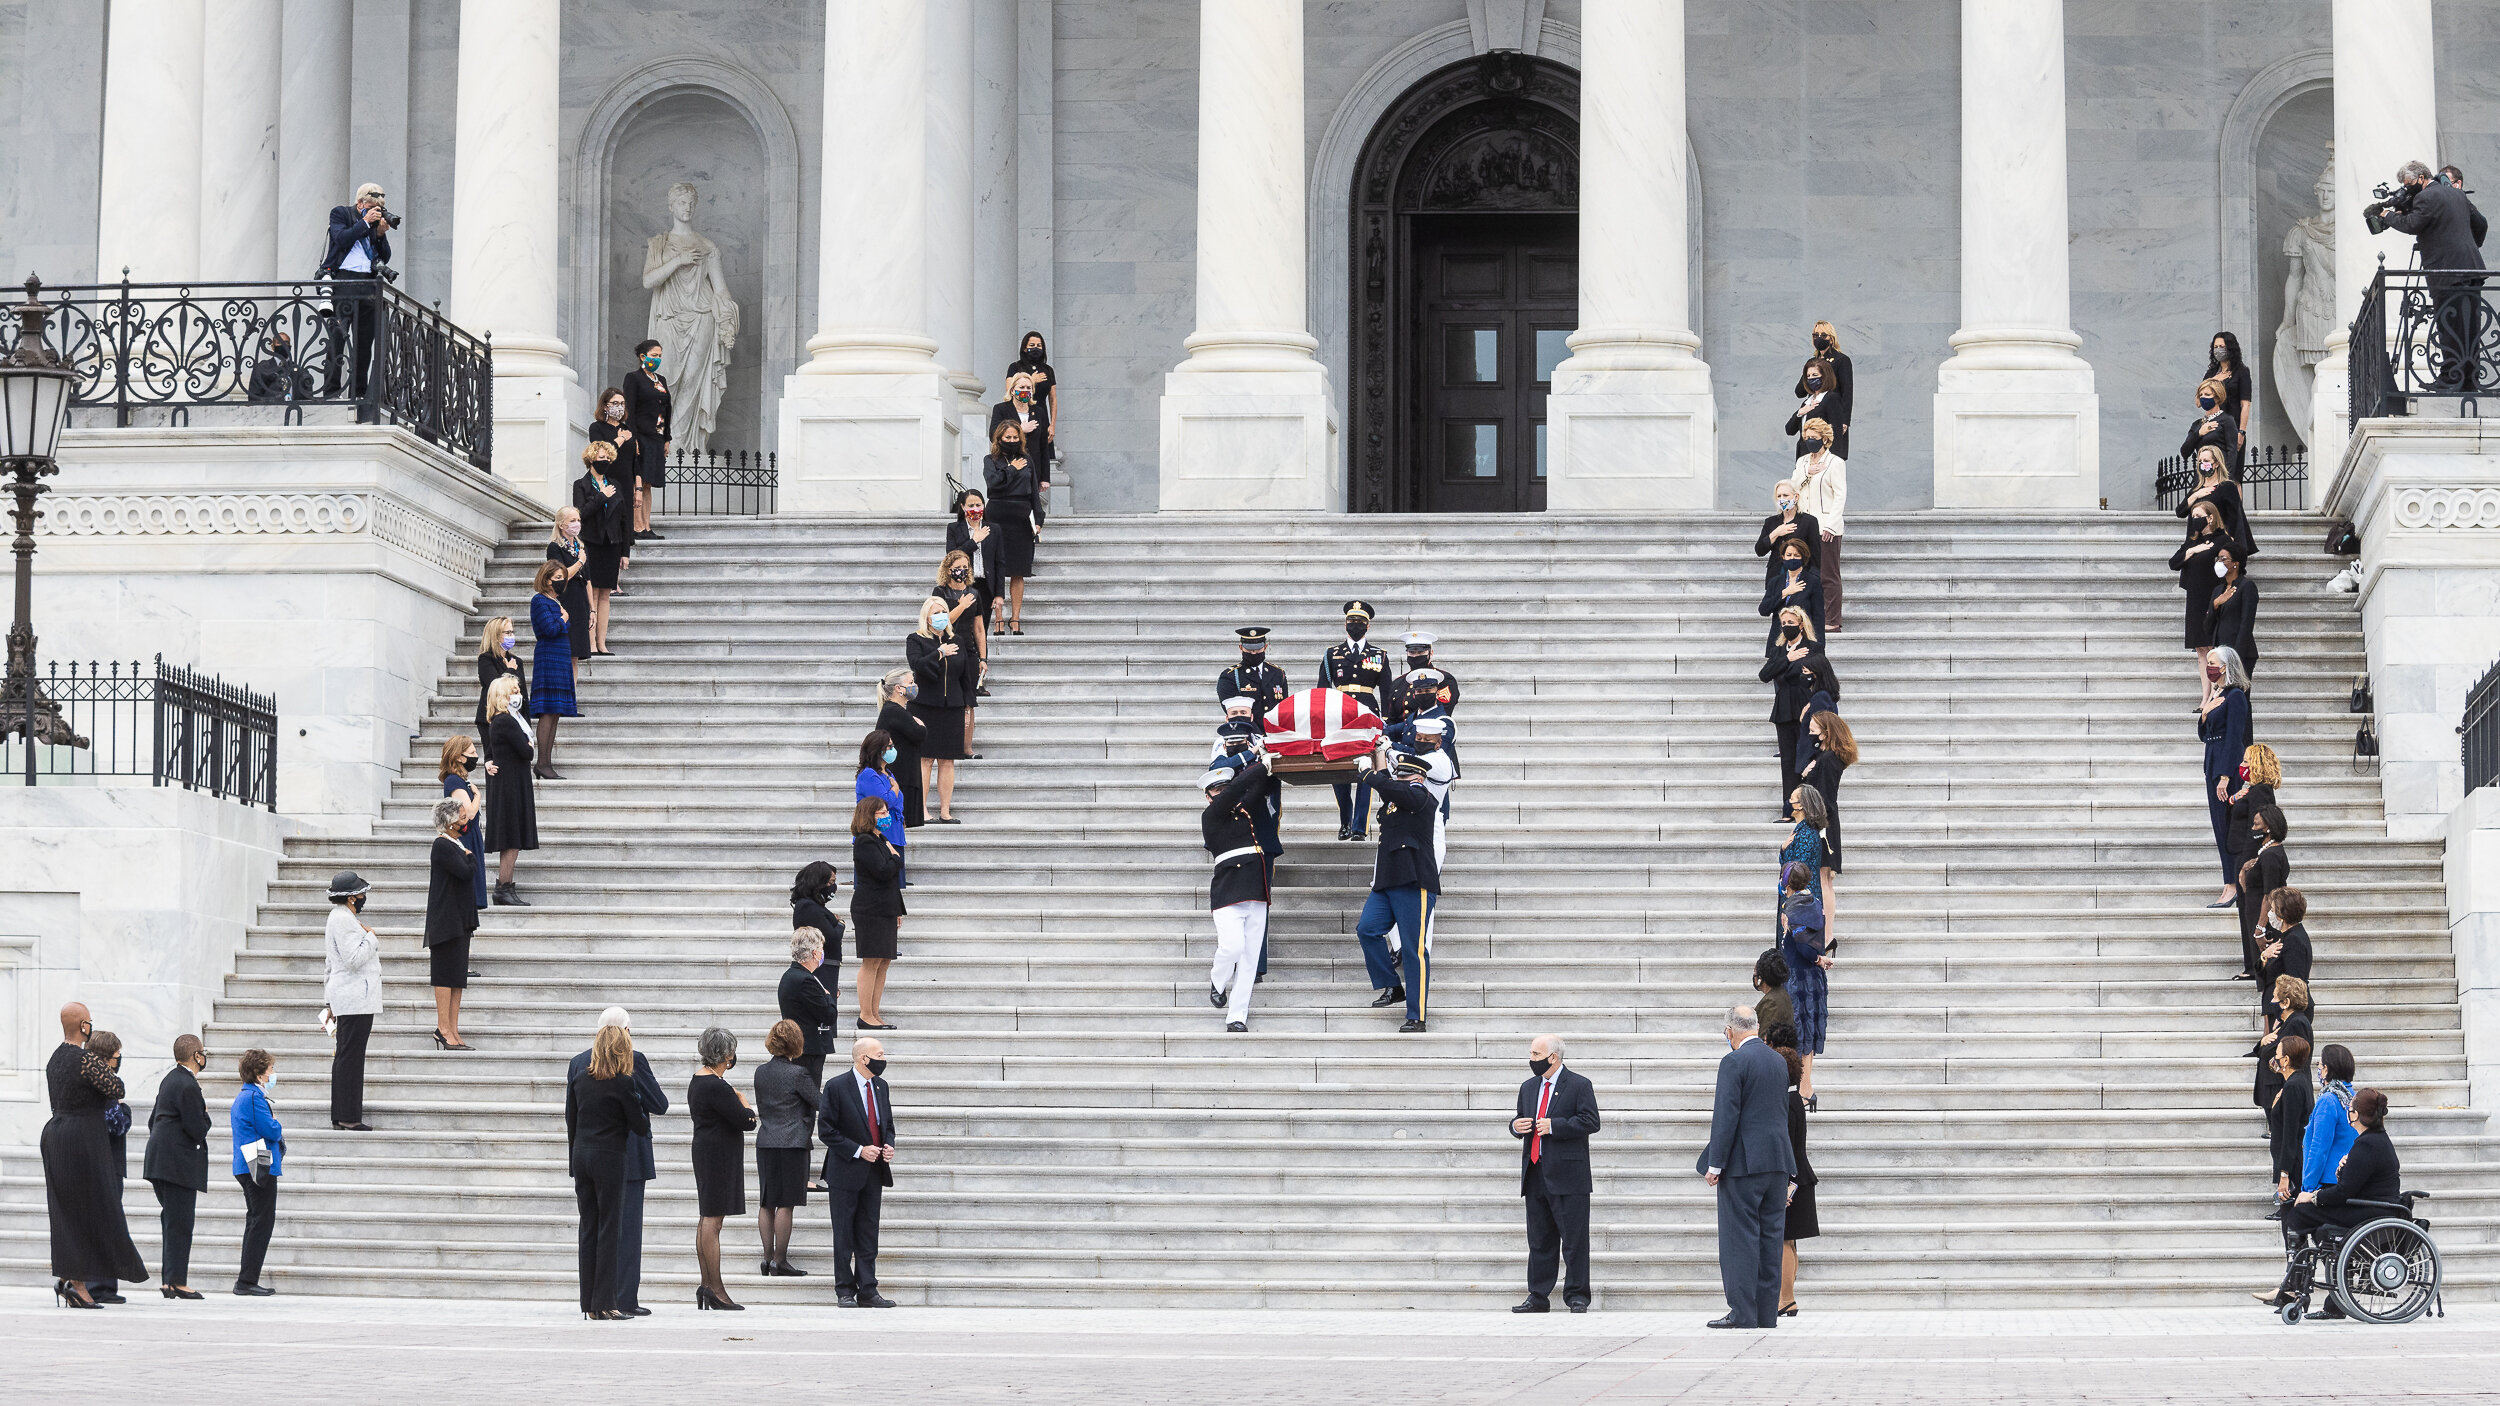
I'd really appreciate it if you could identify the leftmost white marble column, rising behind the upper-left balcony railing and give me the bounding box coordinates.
[95,0,208,283]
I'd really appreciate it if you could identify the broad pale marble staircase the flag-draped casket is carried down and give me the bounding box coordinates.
[0,513,2500,1313]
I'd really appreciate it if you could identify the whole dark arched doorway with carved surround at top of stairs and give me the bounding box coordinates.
[1348,53,1580,513]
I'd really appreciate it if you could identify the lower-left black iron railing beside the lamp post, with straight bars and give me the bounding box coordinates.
[0,655,278,811]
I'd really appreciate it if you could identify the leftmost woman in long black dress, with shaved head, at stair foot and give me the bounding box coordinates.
[43,1006,148,1308]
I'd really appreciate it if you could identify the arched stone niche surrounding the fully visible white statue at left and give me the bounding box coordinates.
[600,90,775,450]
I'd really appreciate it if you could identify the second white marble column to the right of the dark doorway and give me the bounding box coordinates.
[1935,0,2100,508]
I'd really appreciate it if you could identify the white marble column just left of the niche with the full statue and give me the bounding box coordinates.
[445,0,575,505]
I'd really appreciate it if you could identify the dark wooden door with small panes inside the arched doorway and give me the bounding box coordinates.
[1405,215,1580,513]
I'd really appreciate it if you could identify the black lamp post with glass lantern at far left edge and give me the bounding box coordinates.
[0,275,88,786]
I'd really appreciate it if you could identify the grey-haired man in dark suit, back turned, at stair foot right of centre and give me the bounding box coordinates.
[1693,1006,1798,1328]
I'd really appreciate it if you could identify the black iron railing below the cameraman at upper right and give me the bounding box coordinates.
[2350,263,2500,425]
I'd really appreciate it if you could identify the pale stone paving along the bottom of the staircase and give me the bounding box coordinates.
[0,1291,2500,1406]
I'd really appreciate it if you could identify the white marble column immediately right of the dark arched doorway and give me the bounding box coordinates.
[1545,0,1718,513]
